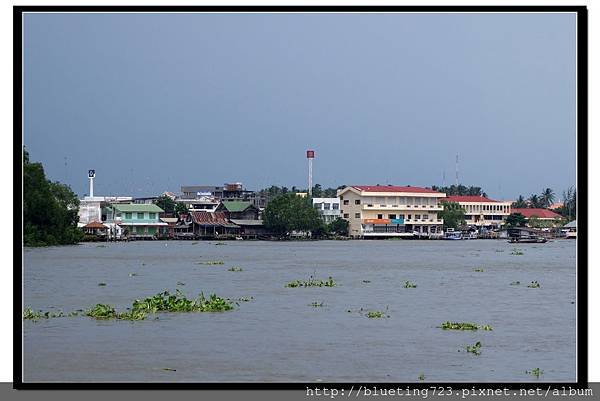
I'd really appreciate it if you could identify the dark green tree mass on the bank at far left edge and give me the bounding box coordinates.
[23,149,83,246]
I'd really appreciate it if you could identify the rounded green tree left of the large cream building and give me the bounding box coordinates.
[263,193,323,236]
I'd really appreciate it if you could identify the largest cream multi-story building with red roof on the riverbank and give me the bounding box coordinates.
[337,185,446,238]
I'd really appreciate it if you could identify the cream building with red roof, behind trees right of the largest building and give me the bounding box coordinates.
[444,195,511,228]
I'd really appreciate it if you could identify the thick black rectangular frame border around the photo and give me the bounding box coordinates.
[13,6,589,390]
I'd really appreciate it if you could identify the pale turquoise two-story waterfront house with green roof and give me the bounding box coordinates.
[106,203,168,239]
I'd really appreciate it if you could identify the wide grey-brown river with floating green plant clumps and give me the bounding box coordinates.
[23,240,576,382]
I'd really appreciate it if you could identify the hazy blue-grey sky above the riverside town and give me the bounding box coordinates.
[23,13,576,199]
